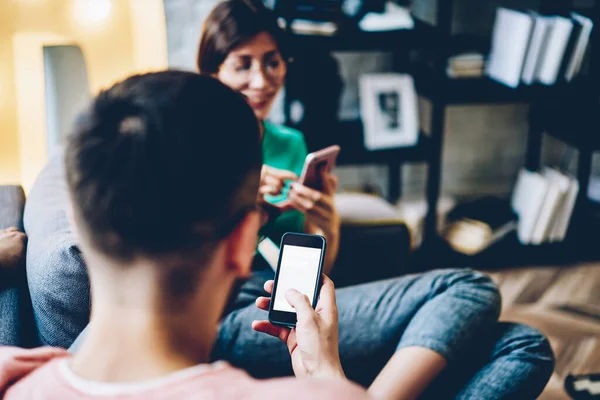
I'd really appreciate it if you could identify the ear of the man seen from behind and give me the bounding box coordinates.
[226,211,260,277]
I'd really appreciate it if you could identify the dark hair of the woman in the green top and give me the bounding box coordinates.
[196,0,289,75]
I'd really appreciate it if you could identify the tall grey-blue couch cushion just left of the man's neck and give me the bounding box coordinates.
[24,154,90,348]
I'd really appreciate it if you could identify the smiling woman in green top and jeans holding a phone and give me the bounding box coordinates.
[197,0,553,399]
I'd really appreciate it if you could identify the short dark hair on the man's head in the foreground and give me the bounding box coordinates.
[65,71,262,261]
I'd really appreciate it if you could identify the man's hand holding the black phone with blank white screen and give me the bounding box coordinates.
[252,275,346,379]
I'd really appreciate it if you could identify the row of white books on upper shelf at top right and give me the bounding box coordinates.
[486,8,594,88]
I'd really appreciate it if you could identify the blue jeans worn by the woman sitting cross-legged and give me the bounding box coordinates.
[74,270,554,400]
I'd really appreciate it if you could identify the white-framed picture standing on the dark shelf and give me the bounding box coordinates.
[359,74,419,150]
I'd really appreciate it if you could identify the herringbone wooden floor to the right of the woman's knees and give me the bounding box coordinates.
[488,264,600,400]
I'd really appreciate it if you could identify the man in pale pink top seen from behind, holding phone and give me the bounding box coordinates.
[0,71,366,400]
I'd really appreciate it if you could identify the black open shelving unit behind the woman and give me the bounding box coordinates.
[286,0,600,267]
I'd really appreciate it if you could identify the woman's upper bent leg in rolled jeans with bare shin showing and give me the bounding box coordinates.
[337,270,500,392]
